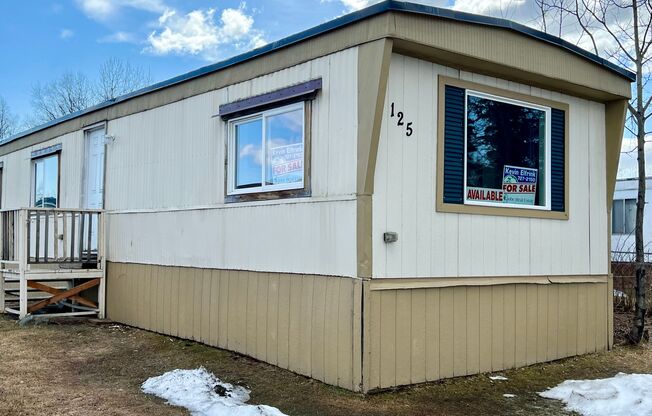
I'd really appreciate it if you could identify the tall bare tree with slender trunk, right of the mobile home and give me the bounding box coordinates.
[539,0,652,343]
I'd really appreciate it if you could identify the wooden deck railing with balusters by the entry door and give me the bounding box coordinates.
[0,208,104,268]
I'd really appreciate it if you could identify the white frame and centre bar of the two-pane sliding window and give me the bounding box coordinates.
[227,101,306,195]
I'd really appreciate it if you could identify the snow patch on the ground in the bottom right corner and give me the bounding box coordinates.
[539,373,652,416]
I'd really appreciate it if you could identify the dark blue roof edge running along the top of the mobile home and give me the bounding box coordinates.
[0,0,636,146]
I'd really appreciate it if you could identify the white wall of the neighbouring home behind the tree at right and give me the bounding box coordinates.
[611,176,652,254]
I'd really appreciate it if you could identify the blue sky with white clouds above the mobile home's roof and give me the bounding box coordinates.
[0,0,640,132]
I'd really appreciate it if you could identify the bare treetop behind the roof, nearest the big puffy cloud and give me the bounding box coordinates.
[95,58,151,102]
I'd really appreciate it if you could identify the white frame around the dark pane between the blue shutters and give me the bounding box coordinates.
[464,89,552,211]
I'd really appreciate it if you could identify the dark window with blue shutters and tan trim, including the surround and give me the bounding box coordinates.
[436,76,569,220]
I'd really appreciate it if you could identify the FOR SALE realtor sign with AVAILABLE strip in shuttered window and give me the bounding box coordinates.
[466,165,538,205]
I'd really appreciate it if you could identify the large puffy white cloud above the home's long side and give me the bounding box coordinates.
[146,4,266,60]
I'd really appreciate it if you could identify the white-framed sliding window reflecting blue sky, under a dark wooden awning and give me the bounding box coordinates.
[227,102,305,195]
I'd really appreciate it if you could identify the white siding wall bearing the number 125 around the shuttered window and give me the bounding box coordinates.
[373,54,610,278]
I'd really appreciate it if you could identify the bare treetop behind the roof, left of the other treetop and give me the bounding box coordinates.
[32,72,96,124]
